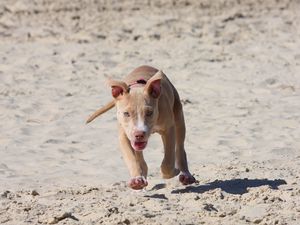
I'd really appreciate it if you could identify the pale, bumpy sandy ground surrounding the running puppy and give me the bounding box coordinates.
[0,0,300,225]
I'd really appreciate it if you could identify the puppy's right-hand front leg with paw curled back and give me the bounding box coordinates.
[161,126,179,179]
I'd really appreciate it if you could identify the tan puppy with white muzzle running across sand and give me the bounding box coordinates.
[87,66,196,189]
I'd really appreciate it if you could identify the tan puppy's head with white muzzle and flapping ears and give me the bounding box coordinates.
[109,71,163,151]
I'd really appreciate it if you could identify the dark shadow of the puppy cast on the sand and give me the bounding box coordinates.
[171,178,287,195]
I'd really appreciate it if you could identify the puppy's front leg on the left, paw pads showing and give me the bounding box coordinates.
[119,127,148,190]
